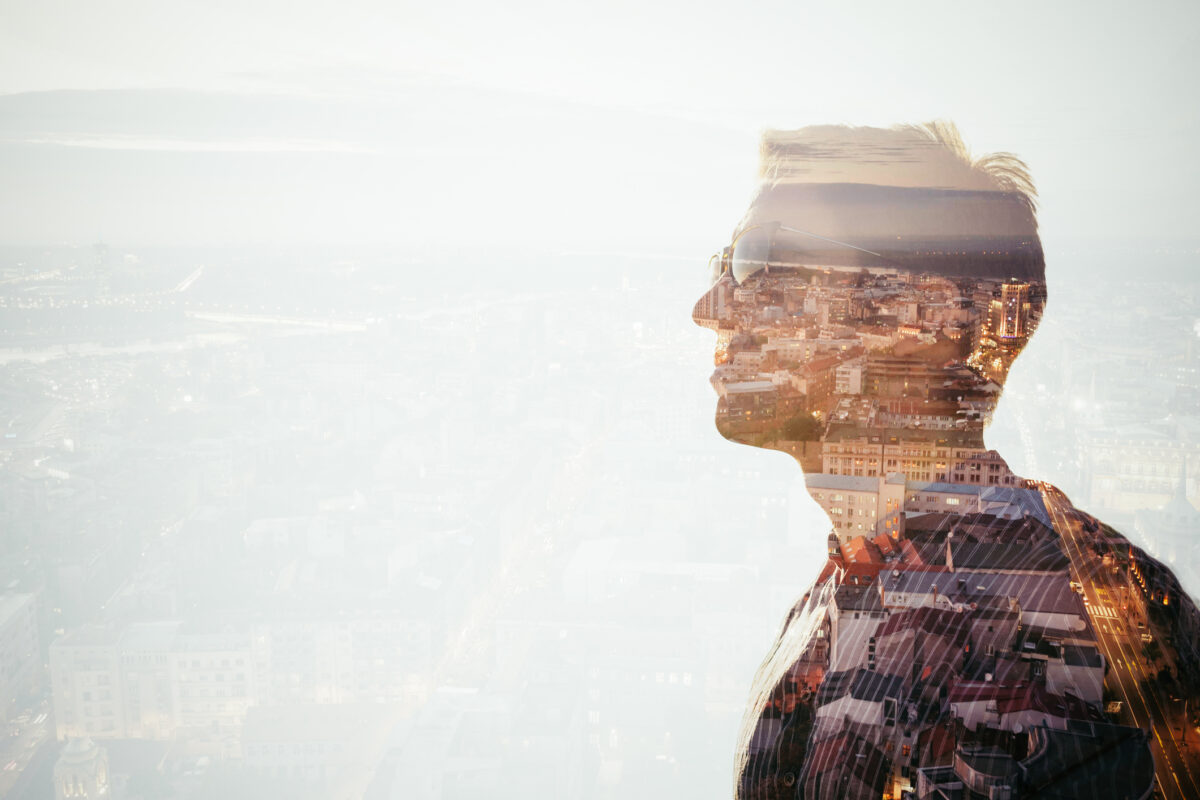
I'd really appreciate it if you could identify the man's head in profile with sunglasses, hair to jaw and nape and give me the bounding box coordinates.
[692,122,1045,482]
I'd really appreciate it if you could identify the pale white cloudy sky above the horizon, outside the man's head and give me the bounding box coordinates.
[0,0,1200,253]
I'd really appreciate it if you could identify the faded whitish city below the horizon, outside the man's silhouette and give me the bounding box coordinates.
[4,235,1200,796]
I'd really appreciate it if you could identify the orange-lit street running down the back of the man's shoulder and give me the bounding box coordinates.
[1042,488,1200,800]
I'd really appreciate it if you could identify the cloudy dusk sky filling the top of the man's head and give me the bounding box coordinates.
[734,121,1045,279]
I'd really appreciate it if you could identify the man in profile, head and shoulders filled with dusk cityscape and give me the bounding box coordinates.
[692,125,1200,800]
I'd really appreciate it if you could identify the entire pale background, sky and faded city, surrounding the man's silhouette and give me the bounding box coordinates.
[0,2,1200,800]
